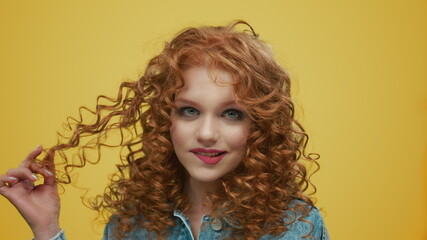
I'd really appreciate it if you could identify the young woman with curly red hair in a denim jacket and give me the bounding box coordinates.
[0,21,329,240]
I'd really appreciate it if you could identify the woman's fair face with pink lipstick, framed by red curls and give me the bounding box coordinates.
[170,66,250,183]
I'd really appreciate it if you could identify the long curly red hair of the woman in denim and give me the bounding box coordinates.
[46,21,318,239]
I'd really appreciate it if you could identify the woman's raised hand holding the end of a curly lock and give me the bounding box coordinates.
[0,146,60,240]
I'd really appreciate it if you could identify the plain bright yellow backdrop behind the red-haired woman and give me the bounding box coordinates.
[0,0,427,240]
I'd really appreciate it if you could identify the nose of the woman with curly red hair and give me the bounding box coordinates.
[196,116,219,147]
